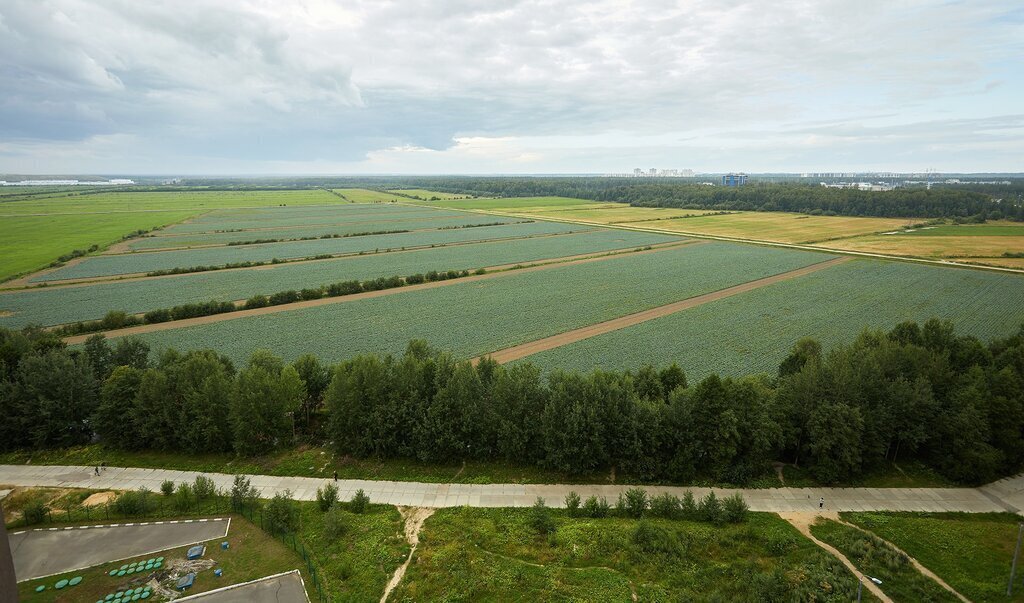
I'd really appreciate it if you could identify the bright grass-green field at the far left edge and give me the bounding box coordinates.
[0,190,341,281]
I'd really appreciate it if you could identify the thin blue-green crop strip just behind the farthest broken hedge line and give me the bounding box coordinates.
[128,214,525,250]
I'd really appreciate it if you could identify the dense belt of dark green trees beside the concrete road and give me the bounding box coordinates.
[0,319,1024,483]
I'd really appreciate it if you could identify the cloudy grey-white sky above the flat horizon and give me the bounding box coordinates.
[0,0,1024,175]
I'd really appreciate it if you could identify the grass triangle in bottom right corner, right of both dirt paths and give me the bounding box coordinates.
[841,512,1024,603]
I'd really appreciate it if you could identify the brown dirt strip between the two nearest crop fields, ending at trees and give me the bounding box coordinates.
[473,257,852,363]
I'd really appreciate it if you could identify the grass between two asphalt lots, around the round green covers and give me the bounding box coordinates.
[18,515,311,603]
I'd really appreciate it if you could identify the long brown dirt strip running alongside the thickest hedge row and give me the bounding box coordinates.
[63,241,705,345]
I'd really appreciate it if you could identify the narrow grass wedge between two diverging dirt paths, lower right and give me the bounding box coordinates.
[811,520,959,603]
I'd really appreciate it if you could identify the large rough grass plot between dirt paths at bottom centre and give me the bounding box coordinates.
[392,508,872,602]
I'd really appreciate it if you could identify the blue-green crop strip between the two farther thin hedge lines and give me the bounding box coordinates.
[32,222,586,282]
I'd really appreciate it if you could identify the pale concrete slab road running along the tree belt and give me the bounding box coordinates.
[0,465,1024,513]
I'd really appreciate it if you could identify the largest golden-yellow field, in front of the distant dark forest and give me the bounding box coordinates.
[630,208,914,242]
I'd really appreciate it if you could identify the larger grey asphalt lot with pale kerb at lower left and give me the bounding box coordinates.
[9,518,230,582]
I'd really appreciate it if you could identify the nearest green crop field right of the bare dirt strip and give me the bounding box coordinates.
[524,260,1024,378]
